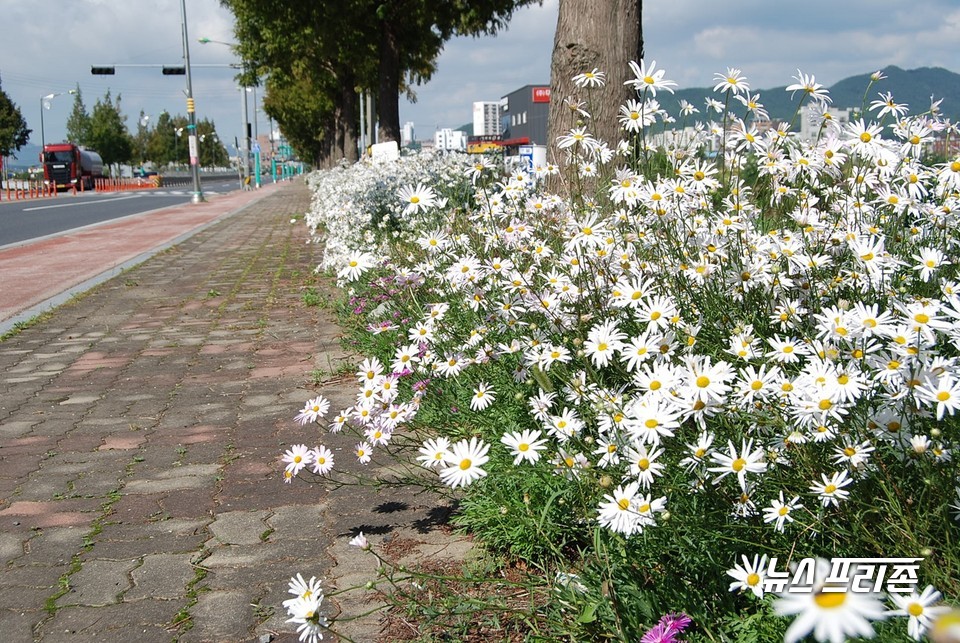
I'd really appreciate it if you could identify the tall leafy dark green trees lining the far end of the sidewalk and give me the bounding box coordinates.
[221,0,540,160]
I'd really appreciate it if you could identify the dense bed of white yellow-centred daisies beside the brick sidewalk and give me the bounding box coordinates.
[285,63,960,641]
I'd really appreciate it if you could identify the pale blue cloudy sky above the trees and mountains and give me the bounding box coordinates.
[0,0,960,157]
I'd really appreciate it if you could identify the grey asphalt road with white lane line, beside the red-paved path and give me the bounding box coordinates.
[0,178,239,247]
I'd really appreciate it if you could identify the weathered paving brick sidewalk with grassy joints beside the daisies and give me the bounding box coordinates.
[0,183,464,643]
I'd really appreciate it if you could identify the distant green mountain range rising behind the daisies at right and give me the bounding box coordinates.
[656,65,960,122]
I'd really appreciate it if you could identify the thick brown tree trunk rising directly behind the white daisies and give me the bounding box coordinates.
[547,0,643,159]
